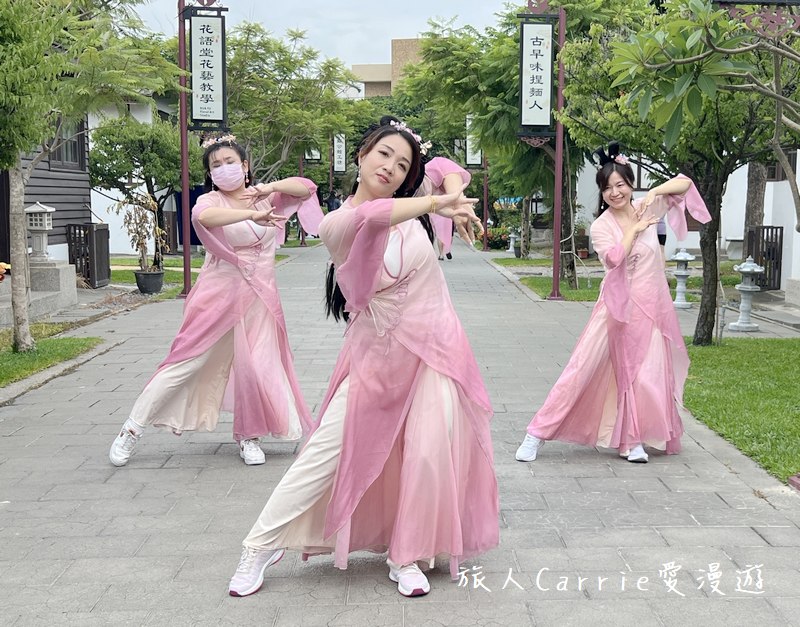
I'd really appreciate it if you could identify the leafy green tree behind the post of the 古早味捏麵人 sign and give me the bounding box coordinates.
[401,9,584,282]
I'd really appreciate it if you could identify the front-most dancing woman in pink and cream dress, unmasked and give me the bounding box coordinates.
[229,117,499,596]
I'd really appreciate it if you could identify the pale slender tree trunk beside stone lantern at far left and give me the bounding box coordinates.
[8,159,36,353]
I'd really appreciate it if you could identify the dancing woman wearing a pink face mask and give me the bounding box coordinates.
[109,136,322,466]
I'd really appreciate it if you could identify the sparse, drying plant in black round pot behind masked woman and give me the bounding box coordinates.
[112,191,165,294]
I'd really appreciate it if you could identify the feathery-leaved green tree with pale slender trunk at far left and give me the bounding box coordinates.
[0,0,178,351]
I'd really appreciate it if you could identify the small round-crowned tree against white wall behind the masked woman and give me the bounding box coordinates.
[89,115,203,270]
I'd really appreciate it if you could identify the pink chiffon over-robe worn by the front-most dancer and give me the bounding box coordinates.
[320,199,499,568]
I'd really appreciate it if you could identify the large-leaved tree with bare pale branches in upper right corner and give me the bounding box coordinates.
[611,0,800,232]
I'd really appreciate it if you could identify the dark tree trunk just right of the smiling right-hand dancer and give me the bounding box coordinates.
[692,172,727,346]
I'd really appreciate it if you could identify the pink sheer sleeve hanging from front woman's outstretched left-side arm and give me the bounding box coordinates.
[319,199,394,312]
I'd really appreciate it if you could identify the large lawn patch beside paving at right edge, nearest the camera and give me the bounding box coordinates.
[684,338,800,481]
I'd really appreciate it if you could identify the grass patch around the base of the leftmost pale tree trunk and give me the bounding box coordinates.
[0,322,102,387]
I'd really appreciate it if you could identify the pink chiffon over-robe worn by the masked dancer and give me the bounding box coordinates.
[148,179,319,432]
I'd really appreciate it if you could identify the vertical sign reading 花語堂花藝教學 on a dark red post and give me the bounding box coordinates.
[189,13,228,130]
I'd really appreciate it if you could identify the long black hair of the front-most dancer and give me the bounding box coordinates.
[325,115,434,322]
